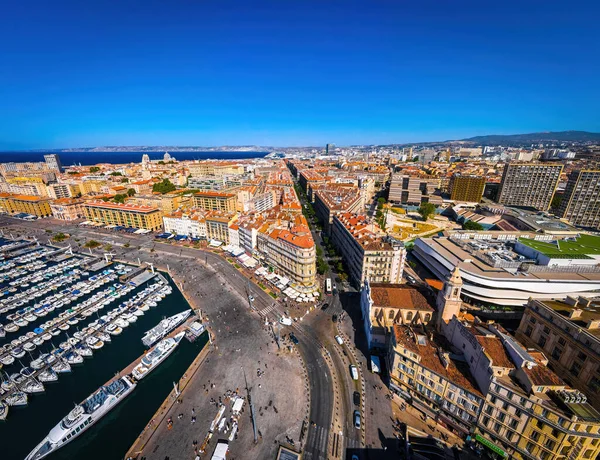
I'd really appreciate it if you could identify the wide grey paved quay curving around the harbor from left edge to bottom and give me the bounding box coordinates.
[2,219,309,460]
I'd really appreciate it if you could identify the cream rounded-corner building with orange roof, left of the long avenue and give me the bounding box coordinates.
[256,225,317,291]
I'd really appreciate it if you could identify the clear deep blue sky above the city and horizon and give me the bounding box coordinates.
[0,0,600,149]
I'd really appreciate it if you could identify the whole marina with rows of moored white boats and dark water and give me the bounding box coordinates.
[0,240,206,459]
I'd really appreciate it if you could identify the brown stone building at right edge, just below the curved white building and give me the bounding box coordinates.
[516,297,600,410]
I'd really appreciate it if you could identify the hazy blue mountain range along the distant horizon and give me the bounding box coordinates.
[6,130,600,152]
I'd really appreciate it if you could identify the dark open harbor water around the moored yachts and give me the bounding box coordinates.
[0,255,208,460]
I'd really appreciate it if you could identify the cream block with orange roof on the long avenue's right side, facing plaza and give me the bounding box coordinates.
[331,212,406,286]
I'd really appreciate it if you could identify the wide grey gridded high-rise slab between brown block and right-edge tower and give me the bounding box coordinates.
[498,162,563,211]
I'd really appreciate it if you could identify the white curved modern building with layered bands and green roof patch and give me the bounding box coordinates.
[413,232,600,306]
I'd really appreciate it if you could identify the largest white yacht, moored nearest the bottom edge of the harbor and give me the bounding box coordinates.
[25,376,136,460]
